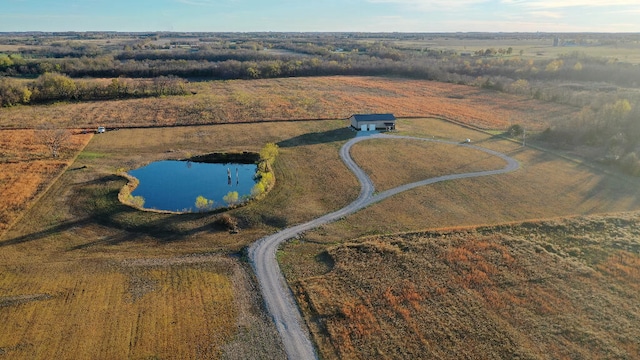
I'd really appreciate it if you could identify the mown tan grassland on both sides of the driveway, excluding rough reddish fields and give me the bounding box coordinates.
[0,118,639,358]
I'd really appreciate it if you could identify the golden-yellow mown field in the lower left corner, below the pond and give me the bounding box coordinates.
[0,256,282,359]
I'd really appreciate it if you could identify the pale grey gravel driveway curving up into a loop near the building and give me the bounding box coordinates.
[249,134,519,360]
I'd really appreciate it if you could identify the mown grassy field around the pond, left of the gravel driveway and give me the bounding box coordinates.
[0,121,357,359]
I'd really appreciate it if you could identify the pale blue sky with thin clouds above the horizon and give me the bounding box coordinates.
[0,0,640,32]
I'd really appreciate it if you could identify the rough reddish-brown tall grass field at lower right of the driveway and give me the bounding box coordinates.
[288,214,640,359]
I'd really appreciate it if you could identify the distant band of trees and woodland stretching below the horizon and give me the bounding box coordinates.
[0,32,640,174]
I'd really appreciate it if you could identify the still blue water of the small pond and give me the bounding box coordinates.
[129,160,257,212]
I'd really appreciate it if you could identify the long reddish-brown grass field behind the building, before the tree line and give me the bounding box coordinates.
[0,76,575,129]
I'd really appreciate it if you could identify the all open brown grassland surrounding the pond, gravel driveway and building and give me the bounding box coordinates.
[0,72,640,358]
